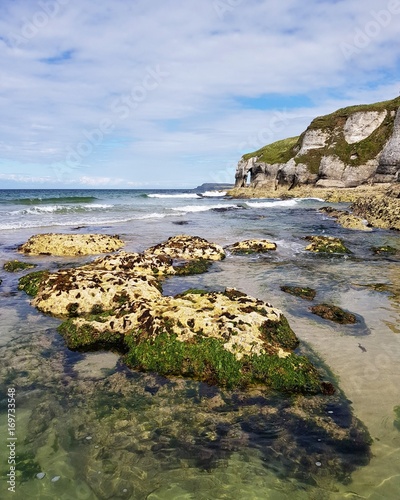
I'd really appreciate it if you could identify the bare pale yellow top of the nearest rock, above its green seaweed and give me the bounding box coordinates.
[69,290,290,359]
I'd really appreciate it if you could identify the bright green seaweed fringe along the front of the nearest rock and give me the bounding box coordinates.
[124,334,321,393]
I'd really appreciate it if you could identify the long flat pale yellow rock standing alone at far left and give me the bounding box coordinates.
[18,233,124,255]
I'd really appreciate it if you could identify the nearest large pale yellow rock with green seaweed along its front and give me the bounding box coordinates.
[59,289,322,392]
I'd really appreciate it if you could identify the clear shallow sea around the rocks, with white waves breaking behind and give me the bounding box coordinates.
[0,189,400,500]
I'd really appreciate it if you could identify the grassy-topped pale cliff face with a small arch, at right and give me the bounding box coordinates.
[235,97,400,189]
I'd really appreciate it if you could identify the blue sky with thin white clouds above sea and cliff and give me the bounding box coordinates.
[0,0,400,189]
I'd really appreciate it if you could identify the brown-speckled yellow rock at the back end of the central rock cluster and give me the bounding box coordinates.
[145,235,225,260]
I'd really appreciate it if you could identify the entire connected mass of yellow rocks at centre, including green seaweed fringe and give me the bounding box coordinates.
[19,236,330,392]
